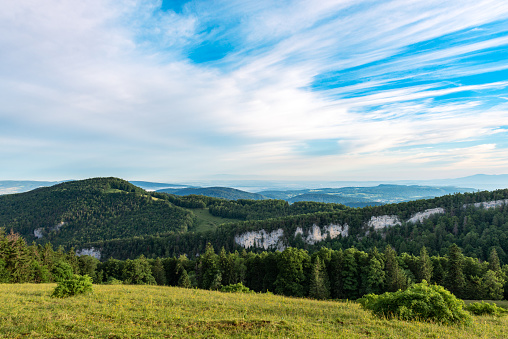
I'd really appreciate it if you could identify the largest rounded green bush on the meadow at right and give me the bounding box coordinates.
[359,280,471,324]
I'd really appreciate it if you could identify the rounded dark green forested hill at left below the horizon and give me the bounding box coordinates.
[0,178,194,245]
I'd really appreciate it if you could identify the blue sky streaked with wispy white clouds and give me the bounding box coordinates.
[0,0,508,182]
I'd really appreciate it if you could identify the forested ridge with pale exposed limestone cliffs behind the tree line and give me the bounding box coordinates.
[79,189,508,263]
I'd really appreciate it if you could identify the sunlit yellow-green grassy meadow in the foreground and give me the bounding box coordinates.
[0,284,508,338]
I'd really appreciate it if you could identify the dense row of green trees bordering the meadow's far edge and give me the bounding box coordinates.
[0,230,508,299]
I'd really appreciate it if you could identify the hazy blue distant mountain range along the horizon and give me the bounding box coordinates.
[0,174,508,207]
